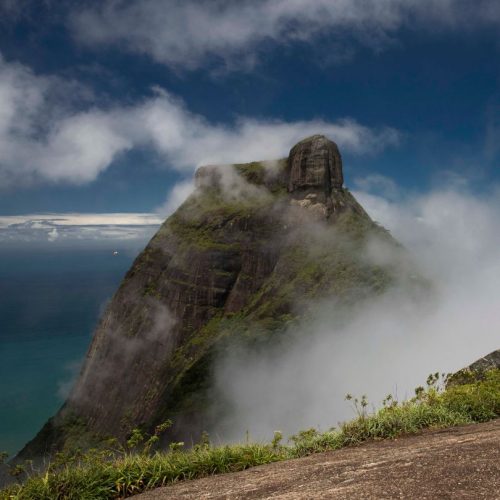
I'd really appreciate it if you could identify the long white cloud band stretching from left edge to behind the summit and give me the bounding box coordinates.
[0,54,399,187]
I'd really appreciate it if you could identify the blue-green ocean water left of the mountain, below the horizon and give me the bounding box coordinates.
[0,242,145,455]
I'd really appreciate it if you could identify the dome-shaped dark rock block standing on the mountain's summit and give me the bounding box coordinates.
[287,135,344,197]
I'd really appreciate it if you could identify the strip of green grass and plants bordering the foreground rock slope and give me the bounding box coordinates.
[0,369,500,500]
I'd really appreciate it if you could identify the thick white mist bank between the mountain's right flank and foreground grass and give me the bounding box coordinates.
[211,186,500,441]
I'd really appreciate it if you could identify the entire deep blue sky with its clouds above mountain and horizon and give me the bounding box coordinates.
[0,0,500,241]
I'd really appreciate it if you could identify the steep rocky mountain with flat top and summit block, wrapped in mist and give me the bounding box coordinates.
[20,136,408,457]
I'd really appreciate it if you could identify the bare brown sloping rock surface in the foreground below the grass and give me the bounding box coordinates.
[135,420,500,500]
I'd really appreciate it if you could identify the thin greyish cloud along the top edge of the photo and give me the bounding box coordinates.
[71,0,500,69]
